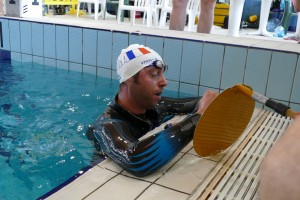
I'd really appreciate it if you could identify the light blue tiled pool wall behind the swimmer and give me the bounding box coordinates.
[0,17,300,110]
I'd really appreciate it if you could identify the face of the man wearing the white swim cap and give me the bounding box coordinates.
[129,67,168,109]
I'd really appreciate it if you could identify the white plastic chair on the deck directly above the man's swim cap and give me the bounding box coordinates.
[117,0,155,27]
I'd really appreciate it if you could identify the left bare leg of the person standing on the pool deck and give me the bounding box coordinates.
[169,0,188,31]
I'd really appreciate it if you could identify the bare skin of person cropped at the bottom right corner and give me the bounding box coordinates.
[259,114,300,200]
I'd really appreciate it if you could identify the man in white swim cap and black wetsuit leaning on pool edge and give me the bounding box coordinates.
[87,44,217,176]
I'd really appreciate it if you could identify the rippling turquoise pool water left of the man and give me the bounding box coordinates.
[0,60,118,200]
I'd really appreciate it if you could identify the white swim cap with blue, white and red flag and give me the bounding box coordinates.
[117,44,162,83]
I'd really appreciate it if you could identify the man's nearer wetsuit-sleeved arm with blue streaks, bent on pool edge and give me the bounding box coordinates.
[94,114,200,176]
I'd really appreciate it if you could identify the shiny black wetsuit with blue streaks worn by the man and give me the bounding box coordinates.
[89,96,200,176]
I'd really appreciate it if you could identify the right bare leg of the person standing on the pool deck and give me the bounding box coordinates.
[197,0,216,33]
